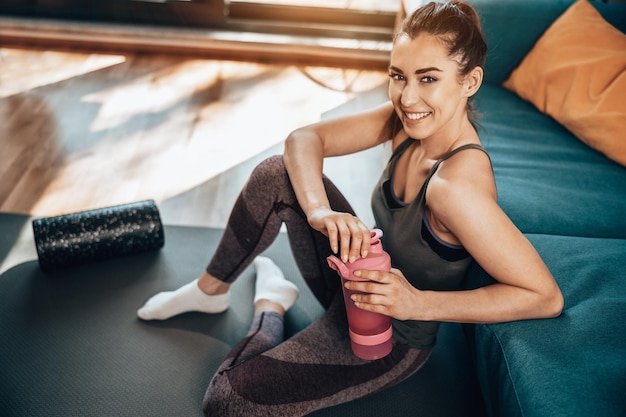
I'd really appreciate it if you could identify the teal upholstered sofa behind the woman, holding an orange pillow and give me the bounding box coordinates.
[465,0,626,417]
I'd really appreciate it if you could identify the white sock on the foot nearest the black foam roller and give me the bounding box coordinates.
[137,279,230,320]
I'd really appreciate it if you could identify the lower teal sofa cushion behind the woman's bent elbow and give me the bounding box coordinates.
[470,235,626,417]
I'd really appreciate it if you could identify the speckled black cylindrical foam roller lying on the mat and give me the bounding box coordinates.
[32,200,165,271]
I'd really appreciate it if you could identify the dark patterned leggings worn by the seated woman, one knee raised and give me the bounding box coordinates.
[203,156,430,417]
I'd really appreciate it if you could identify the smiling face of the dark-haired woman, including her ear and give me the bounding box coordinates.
[389,34,482,140]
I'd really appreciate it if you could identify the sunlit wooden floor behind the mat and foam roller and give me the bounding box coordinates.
[0,48,387,232]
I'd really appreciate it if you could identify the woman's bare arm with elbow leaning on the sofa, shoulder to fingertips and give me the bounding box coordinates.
[348,151,563,323]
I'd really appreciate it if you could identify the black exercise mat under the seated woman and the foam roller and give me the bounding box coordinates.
[0,214,484,417]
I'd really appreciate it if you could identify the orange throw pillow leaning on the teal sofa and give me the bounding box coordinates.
[503,0,626,166]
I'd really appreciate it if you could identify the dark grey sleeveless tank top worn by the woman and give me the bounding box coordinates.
[372,138,486,349]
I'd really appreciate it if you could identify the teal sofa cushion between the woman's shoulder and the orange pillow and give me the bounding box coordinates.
[476,84,626,239]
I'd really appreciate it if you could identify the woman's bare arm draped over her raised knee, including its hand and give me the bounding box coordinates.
[283,103,393,261]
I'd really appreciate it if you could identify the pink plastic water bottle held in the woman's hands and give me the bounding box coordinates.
[327,229,393,360]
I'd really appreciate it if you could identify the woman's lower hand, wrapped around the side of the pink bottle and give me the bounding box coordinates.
[344,268,424,320]
